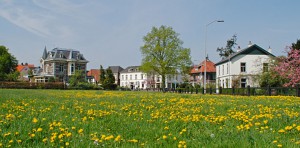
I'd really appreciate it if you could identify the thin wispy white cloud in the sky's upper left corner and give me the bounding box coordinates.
[0,1,73,38]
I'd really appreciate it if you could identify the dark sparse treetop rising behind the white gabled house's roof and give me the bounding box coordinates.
[217,35,237,58]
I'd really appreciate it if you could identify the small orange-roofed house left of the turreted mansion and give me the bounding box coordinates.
[16,63,34,81]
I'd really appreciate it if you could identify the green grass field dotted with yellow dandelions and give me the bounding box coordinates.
[0,89,300,148]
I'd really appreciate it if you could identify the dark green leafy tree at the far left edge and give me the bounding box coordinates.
[0,46,19,81]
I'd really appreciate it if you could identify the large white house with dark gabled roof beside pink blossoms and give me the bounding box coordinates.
[216,42,275,88]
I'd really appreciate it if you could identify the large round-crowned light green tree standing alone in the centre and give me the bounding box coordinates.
[141,25,192,88]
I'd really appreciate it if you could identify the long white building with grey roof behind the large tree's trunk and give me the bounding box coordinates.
[120,66,182,89]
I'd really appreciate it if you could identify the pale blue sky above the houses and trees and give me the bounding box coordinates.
[0,0,300,69]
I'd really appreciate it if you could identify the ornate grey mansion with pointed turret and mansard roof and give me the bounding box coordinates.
[34,47,88,82]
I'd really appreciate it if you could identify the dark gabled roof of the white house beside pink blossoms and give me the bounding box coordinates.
[216,44,275,65]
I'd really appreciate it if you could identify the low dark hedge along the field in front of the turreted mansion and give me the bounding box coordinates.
[0,82,66,89]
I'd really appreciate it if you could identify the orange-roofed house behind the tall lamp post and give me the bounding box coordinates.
[190,58,216,86]
